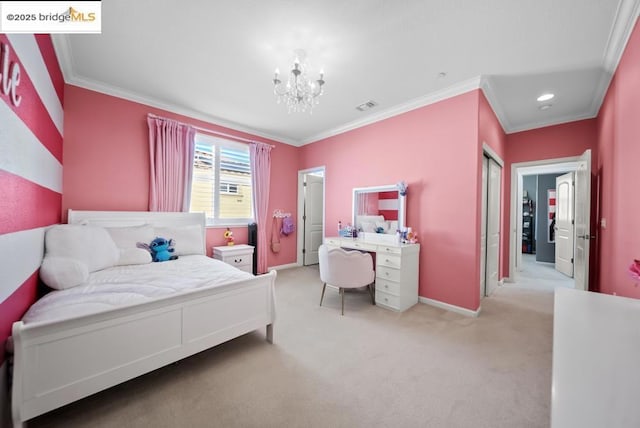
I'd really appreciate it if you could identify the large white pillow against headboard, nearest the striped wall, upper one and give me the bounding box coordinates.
[45,224,120,272]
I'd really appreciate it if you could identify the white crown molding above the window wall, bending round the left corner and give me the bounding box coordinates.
[52,34,300,146]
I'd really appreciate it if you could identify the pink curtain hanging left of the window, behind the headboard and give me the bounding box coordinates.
[147,115,196,211]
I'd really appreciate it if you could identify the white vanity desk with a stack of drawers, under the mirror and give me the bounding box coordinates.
[324,237,420,311]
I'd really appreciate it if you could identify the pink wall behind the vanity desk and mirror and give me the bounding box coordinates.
[300,91,479,310]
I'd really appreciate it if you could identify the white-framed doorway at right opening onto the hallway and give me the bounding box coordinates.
[509,151,591,289]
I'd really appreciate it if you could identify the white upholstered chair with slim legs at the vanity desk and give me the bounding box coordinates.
[318,245,376,315]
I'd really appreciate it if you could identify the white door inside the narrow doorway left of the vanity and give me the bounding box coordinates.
[302,174,324,266]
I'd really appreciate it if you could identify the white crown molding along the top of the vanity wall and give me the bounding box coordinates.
[301,76,481,145]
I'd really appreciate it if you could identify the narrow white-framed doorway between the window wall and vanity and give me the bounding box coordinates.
[297,166,325,266]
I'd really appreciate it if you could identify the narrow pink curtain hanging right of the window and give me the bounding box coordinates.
[249,143,271,273]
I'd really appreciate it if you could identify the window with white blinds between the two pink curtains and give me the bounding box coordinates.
[189,134,253,226]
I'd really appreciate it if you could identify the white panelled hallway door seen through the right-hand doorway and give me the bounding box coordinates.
[554,172,574,277]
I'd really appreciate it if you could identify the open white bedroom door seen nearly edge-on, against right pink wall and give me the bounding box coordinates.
[574,150,592,290]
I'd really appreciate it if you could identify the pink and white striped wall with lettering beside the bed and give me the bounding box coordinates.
[0,34,64,364]
